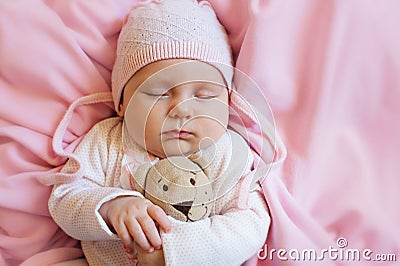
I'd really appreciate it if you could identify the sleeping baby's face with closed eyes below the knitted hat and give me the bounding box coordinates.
[121,59,229,158]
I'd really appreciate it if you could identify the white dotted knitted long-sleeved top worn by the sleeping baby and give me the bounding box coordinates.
[49,118,270,265]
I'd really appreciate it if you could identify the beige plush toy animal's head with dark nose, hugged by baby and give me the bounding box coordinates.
[131,156,213,222]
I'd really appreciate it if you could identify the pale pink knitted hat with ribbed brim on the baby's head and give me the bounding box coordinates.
[112,0,233,111]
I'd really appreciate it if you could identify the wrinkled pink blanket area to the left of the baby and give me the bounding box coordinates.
[0,0,132,265]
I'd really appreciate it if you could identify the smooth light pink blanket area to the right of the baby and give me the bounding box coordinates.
[213,0,400,265]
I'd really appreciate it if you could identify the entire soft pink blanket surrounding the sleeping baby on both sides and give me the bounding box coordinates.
[0,0,400,266]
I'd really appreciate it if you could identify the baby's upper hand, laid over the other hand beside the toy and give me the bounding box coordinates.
[99,196,172,252]
